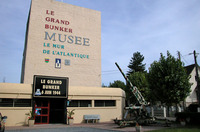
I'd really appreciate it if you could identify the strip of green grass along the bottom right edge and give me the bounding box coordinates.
[151,127,200,132]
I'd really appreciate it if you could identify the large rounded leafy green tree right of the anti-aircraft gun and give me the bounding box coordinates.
[148,51,191,106]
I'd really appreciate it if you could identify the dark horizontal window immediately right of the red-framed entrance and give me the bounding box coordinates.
[68,100,92,107]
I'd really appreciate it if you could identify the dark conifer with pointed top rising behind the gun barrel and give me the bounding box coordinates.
[127,52,146,75]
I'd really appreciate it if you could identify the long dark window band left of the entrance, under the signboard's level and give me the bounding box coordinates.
[0,99,31,107]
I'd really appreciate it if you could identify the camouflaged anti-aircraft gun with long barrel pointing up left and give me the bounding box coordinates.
[115,62,154,127]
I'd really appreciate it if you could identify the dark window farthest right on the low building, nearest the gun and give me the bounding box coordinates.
[94,100,116,107]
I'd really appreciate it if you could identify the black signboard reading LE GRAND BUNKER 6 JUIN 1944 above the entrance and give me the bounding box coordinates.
[33,75,68,98]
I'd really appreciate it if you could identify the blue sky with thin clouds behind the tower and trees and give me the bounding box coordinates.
[0,0,200,85]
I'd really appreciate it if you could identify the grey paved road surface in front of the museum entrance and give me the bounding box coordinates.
[5,127,119,132]
